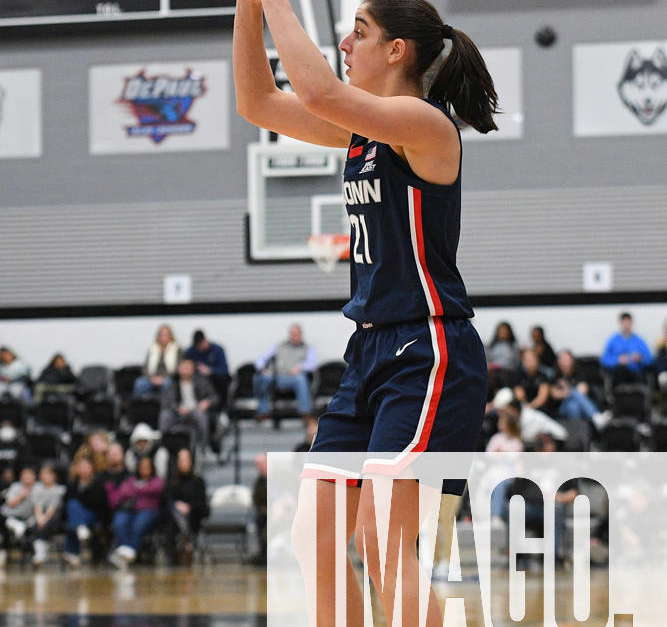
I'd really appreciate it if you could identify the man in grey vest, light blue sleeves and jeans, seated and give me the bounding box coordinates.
[254,324,317,421]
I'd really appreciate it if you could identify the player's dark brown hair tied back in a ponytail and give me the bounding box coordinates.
[365,0,499,133]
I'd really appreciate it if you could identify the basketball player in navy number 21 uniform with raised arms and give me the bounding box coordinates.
[234,0,497,627]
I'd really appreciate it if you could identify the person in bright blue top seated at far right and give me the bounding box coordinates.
[600,312,653,385]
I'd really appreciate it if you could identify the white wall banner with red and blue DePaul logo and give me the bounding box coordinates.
[89,61,230,154]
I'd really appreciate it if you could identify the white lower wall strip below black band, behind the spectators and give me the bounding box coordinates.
[0,304,667,375]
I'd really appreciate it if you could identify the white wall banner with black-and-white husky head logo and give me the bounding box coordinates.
[573,41,667,137]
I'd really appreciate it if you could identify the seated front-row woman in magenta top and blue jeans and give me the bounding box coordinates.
[109,457,164,569]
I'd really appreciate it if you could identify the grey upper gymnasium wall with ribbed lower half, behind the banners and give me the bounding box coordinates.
[0,0,667,313]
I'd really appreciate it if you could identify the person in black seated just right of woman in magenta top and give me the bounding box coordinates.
[166,448,209,564]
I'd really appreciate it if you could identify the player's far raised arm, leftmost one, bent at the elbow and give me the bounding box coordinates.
[233,0,350,147]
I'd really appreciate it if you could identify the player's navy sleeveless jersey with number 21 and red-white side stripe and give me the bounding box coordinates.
[343,100,473,325]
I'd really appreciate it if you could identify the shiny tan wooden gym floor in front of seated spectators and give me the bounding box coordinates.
[0,563,632,627]
